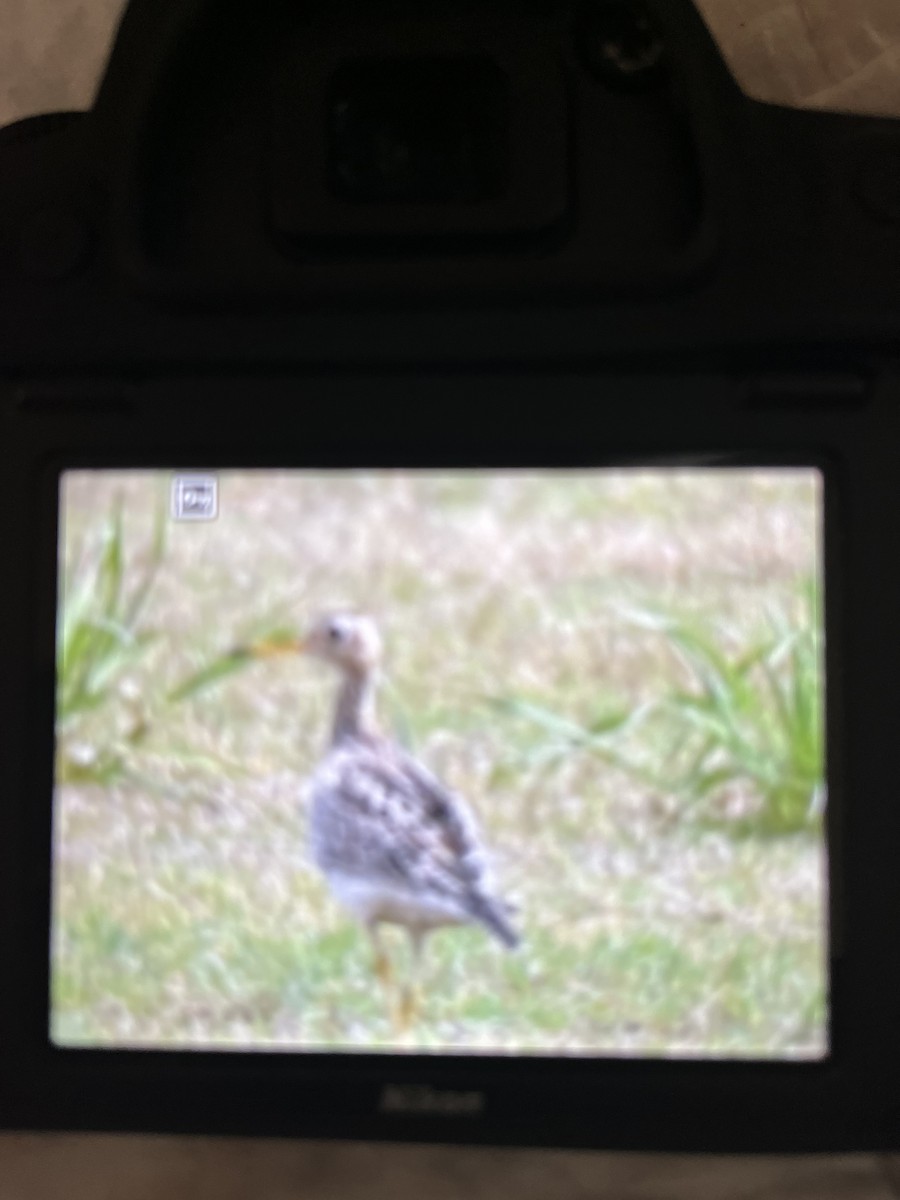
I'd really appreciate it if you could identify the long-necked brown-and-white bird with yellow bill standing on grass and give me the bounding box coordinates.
[247,612,520,1028]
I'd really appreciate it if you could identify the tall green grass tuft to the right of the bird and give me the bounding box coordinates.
[491,582,824,835]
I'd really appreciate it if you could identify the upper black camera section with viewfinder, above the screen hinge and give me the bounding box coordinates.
[0,0,900,364]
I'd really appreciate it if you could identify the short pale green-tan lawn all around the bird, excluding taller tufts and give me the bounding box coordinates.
[53,473,827,1057]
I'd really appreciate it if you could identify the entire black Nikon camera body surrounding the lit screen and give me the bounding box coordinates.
[0,0,900,1150]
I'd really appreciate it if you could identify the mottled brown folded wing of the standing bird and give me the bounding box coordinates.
[312,744,494,910]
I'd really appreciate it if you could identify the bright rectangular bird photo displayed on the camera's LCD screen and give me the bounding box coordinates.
[50,467,828,1060]
